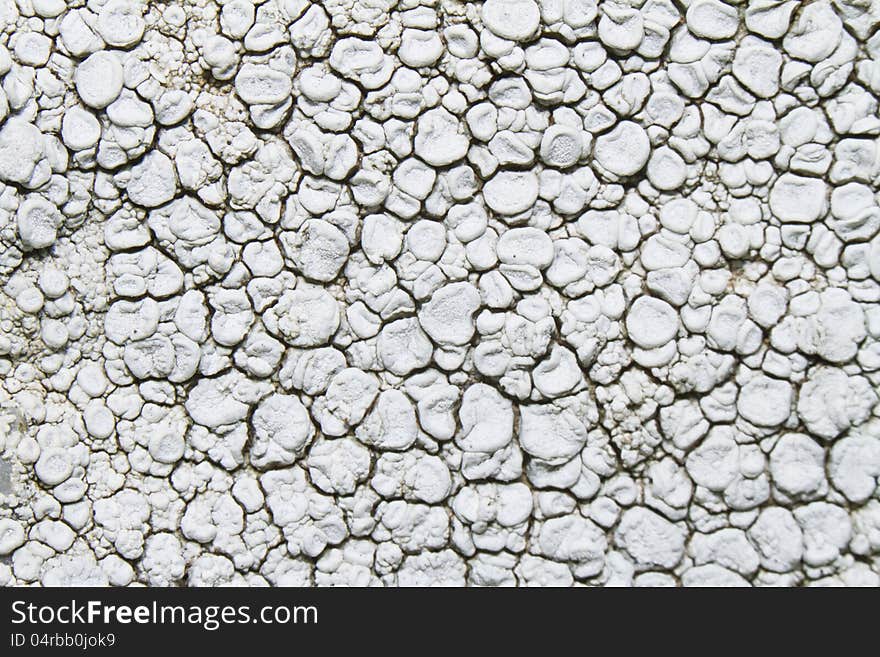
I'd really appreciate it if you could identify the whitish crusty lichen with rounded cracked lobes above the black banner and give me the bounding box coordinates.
[0,0,880,586]
